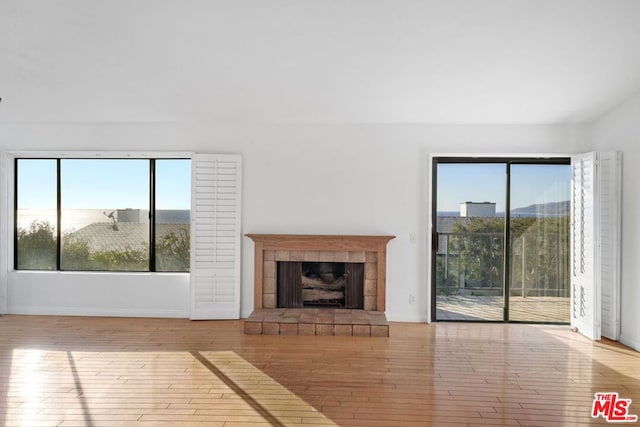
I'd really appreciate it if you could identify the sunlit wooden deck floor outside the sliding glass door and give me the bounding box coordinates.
[436,295,570,323]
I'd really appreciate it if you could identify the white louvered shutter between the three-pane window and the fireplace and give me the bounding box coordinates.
[190,154,242,320]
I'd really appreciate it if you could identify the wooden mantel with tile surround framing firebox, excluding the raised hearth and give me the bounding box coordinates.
[246,233,395,311]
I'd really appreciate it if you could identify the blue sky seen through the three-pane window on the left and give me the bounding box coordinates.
[18,159,191,209]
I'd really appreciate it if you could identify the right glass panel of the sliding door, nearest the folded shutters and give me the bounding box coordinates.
[508,164,571,322]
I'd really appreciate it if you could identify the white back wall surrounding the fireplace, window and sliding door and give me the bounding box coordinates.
[0,123,584,321]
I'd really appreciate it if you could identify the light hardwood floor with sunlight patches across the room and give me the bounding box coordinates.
[0,315,640,427]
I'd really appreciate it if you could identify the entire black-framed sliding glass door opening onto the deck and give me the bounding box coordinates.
[432,158,571,323]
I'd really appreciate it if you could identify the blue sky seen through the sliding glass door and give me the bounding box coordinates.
[437,163,571,212]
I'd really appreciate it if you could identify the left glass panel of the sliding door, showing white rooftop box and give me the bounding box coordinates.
[434,162,507,321]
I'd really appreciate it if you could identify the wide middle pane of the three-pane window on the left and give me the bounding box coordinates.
[60,159,149,271]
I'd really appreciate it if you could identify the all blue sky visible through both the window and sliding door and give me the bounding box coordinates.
[18,159,571,212]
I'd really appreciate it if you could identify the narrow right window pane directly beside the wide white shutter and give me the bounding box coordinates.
[156,159,191,271]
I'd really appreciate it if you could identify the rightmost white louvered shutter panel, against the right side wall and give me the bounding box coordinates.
[598,152,622,340]
